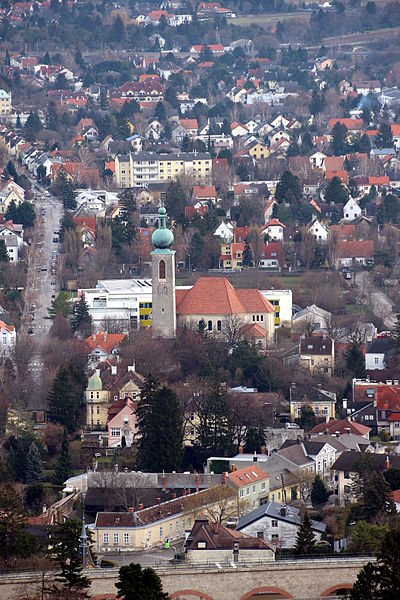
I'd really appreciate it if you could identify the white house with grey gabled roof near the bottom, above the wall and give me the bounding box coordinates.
[236,501,326,548]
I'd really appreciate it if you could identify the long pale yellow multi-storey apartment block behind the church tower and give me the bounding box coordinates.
[115,152,212,188]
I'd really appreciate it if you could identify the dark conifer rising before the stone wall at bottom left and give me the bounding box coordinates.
[49,520,90,598]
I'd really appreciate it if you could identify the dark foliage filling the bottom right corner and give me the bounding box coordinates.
[350,529,400,600]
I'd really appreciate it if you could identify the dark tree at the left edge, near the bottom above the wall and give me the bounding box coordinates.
[0,483,36,566]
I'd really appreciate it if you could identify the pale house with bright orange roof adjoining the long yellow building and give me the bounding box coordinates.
[226,465,269,515]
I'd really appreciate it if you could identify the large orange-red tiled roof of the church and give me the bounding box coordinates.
[176,277,274,315]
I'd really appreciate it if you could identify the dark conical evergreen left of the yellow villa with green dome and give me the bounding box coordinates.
[48,365,80,433]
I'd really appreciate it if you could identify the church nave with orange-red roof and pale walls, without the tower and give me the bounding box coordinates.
[176,277,275,347]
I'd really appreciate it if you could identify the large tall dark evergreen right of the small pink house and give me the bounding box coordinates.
[137,375,183,472]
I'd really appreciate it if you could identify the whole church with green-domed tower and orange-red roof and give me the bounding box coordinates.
[151,206,275,348]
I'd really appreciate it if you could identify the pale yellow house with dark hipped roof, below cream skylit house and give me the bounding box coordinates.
[290,384,336,422]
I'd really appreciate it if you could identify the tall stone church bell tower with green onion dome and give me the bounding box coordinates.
[151,206,176,338]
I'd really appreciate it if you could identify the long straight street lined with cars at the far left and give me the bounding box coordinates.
[18,182,62,396]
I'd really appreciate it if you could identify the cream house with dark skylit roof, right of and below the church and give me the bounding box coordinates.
[299,332,335,377]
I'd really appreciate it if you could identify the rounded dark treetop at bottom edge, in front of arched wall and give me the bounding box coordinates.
[115,563,168,600]
